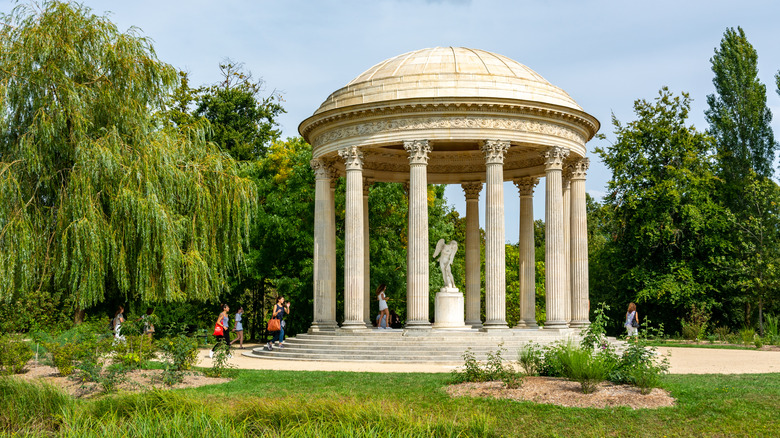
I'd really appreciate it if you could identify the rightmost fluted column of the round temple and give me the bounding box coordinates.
[571,158,590,327]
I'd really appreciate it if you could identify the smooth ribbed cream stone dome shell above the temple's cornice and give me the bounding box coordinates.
[314,47,582,115]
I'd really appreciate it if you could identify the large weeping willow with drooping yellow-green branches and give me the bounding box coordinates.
[0,1,256,309]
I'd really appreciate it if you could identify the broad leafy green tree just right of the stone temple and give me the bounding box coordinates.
[594,88,725,327]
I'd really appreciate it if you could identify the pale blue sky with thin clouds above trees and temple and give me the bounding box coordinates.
[0,0,780,243]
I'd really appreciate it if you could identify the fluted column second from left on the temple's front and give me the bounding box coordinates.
[339,146,366,329]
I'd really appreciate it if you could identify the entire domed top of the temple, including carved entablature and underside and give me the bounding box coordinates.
[298,47,599,184]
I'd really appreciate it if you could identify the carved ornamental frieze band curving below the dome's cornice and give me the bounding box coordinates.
[312,113,587,148]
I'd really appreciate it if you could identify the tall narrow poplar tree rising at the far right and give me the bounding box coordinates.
[705,27,777,190]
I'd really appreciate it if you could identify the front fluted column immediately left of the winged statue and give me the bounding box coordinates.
[404,140,431,328]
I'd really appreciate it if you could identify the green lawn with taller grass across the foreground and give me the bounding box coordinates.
[0,370,780,438]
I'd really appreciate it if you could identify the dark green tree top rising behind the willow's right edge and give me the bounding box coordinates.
[194,61,284,161]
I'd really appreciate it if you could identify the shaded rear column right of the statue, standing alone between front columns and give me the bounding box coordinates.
[514,177,539,328]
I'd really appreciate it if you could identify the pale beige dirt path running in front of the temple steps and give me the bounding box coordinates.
[199,344,780,374]
